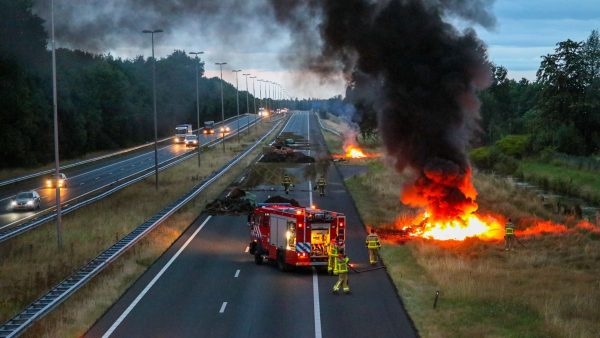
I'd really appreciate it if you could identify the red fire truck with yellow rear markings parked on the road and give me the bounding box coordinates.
[248,203,346,271]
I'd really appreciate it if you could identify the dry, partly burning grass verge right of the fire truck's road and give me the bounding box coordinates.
[347,157,600,337]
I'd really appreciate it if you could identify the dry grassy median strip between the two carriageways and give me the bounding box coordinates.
[0,117,282,337]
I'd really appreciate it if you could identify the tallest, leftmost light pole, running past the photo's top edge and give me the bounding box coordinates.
[50,0,63,249]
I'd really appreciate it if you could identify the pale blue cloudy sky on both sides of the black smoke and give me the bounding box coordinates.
[42,0,600,98]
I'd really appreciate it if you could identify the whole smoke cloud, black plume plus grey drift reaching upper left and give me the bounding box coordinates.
[31,0,495,214]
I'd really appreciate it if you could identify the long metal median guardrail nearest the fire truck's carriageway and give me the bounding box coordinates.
[0,114,281,338]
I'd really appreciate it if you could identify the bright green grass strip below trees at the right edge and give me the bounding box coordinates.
[519,159,600,203]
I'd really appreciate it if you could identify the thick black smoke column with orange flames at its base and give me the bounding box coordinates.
[271,0,495,217]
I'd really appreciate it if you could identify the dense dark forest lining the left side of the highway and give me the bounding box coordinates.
[0,0,328,168]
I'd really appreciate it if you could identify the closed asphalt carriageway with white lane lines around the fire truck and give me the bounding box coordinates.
[85,112,417,338]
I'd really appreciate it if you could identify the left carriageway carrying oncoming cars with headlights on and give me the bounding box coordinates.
[0,115,255,234]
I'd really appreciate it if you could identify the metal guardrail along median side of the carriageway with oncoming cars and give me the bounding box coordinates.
[0,118,260,243]
